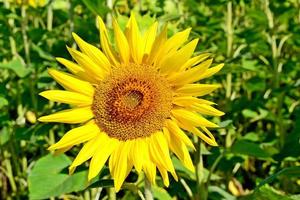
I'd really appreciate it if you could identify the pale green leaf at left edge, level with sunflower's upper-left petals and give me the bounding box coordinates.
[0,57,31,78]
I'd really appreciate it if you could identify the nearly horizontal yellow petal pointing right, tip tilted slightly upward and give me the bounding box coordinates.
[176,84,221,96]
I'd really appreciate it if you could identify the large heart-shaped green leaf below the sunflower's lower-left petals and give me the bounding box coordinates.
[28,154,88,199]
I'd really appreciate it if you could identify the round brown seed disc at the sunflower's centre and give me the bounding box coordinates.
[92,64,172,141]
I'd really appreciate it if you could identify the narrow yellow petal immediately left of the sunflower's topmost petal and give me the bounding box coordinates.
[113,18,130,63]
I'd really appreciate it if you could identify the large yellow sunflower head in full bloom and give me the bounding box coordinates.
[39,14,224,191]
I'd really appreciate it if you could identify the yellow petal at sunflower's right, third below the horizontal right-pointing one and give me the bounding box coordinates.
[171,109,218,128]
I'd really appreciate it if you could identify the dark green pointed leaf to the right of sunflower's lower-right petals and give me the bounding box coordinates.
[231,140,271,159]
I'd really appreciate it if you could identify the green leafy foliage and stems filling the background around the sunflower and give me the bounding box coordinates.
[0,0,300,200]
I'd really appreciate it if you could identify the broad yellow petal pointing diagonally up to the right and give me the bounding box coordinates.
[158,39,199,74]
